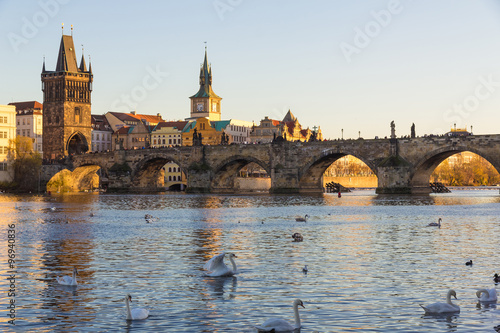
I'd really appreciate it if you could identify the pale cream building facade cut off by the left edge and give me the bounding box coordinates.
[0,105,16,182]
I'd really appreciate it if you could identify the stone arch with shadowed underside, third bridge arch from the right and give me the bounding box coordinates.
[210,155,271,193]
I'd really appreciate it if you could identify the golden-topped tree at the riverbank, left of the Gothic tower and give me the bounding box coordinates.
[8,136,42,191]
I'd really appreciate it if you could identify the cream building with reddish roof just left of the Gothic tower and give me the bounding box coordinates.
[9,101,43,155]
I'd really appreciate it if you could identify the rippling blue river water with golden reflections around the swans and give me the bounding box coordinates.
[0,190,500,332]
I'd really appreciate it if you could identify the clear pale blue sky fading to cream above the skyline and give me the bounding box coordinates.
[0,0,500,139]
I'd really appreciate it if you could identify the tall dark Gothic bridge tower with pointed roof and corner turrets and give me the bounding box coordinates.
[42,28,93,159]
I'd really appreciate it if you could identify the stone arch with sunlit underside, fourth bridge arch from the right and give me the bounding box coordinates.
[131,154,187,191]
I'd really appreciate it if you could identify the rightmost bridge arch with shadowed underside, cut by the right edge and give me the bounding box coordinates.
[410,146,500,190]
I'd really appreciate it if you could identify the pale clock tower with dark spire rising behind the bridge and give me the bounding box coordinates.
[188,47,222,121]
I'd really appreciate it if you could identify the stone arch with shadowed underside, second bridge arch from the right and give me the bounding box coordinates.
[299,149,377,192]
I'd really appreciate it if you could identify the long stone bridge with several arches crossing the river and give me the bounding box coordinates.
[62,135,500,193]
